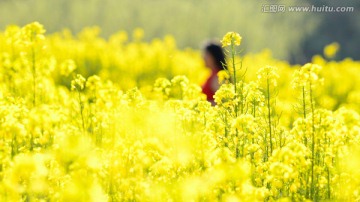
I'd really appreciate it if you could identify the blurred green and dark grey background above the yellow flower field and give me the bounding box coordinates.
[0,0,360,64]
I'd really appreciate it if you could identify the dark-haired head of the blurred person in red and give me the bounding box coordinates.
[204,42,226,70]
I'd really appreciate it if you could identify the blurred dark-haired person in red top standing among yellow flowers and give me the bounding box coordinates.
[202,43,226,105]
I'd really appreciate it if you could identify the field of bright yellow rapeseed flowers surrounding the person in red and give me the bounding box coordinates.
[0,22,360,202]
